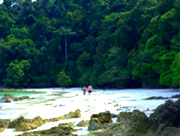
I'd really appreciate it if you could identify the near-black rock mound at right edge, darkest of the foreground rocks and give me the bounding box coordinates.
[149,99,180,136]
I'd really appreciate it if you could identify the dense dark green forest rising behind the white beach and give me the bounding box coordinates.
[0,0,180,88]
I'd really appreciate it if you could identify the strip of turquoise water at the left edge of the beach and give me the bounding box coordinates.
[0,90,44,99]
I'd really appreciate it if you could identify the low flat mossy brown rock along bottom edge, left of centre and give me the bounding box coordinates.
[18,123,77,136]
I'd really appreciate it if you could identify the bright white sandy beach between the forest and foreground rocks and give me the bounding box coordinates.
[0,88,180,136]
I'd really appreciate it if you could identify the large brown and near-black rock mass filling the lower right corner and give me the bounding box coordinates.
[86,99,180,136]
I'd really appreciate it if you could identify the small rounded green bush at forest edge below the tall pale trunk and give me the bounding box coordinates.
[57,70,72,87]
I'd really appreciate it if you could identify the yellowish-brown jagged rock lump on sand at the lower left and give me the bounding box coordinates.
[9,116,47,131]
